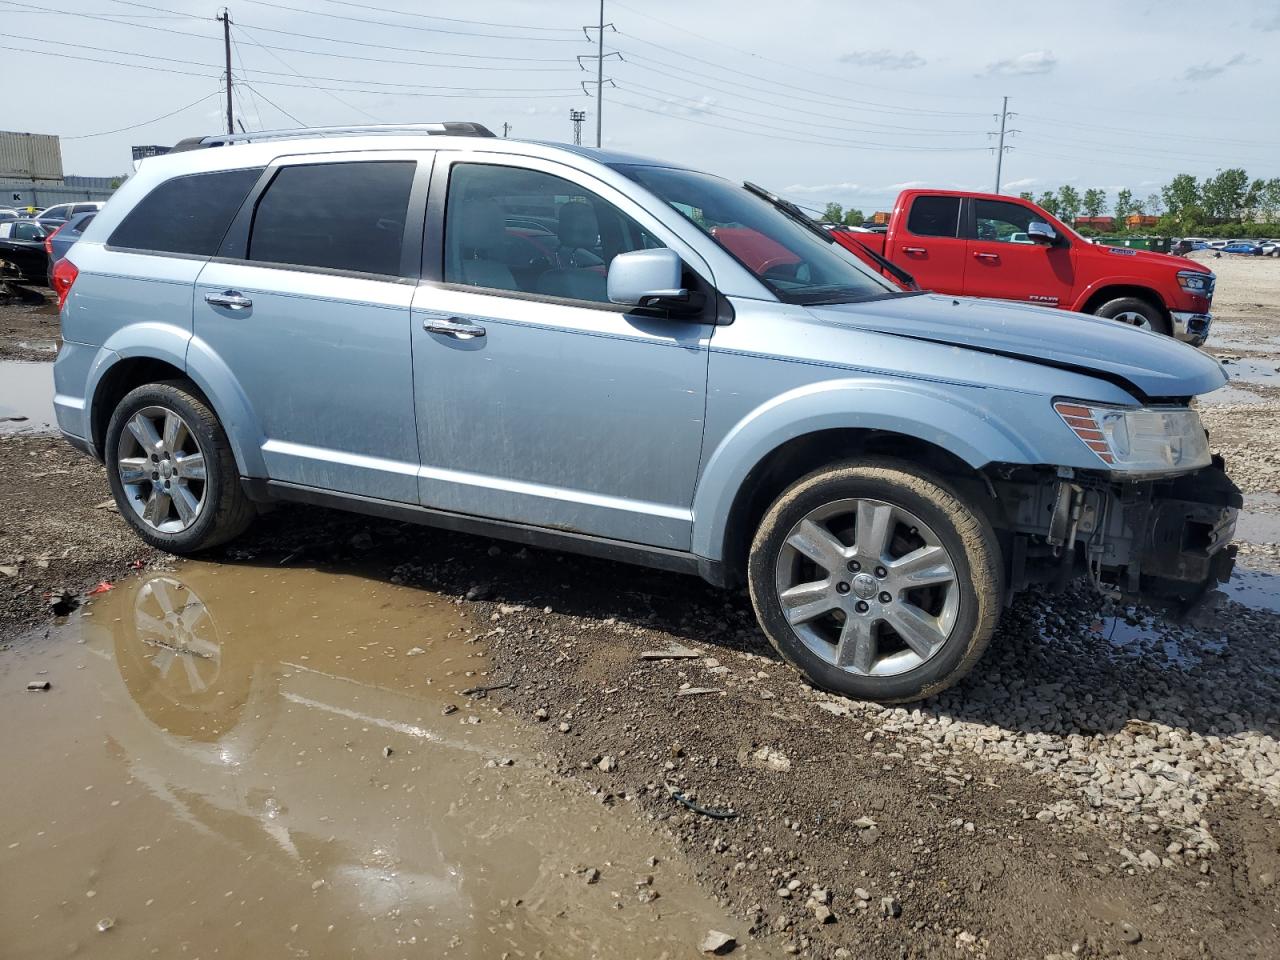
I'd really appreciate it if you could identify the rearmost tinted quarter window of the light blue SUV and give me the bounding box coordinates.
[108,166,262,257]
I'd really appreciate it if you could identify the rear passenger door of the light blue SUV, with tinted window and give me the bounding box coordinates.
[192,152,430,503]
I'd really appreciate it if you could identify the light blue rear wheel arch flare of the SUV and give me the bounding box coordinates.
[86,323,266,476]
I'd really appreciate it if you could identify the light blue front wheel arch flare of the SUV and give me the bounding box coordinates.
[692,378,1039,561]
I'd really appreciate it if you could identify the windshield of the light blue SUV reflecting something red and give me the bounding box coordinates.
[616,164,900,303]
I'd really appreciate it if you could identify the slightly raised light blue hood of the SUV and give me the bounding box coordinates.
[808,294,1226,398]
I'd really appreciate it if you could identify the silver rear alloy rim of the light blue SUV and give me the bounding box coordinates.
[116,407,209,534]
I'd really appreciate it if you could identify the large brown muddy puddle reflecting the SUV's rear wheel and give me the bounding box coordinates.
[0,563,762,960]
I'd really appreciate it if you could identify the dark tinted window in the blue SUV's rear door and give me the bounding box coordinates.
[248,160,416,276]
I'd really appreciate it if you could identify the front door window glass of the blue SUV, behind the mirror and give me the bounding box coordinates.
[444,164,663,303]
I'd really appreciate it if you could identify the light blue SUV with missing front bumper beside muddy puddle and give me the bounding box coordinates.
[54,123,1240,701]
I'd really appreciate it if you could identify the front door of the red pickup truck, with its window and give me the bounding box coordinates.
[964,198,1075,306]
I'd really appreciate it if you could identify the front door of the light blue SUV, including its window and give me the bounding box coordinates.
[412,152,714,550]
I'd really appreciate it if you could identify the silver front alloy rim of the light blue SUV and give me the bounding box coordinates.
[774,499,960,676]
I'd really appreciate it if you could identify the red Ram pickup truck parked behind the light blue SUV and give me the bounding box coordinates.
[832,189,1215,347]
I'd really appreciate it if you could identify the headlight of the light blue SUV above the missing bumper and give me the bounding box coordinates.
[1053,401,1210,474]
